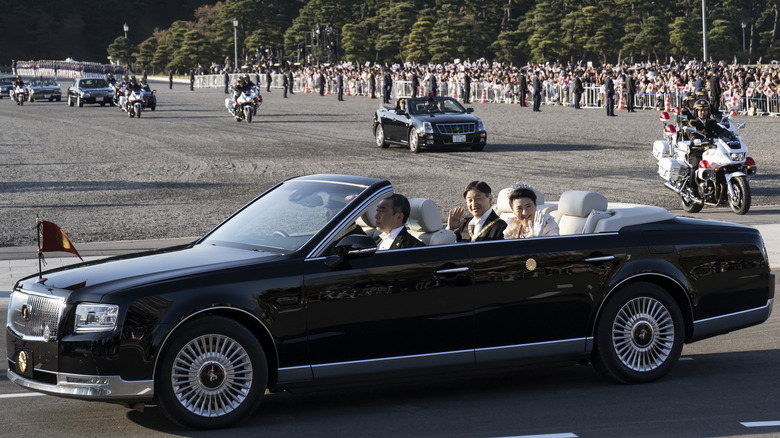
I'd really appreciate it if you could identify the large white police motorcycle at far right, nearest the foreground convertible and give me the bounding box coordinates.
[653,101,757,214]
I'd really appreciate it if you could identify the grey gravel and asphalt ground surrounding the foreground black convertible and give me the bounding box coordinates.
[0,78,780,437]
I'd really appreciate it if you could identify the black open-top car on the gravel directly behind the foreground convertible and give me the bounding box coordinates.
[374,96,487,153]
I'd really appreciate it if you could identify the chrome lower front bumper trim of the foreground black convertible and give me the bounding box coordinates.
[8,370,154,401]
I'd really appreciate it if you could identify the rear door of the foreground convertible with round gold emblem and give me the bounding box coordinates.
[470,233,625,363]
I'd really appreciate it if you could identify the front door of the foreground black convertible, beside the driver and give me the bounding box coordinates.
[304,245,474,379]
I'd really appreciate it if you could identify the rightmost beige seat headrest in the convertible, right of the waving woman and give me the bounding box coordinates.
[553,190,612,235]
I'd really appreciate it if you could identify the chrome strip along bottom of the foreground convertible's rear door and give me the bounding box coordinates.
[476,337,593,363]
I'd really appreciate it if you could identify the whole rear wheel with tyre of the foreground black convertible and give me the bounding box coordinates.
[591,283,685,383]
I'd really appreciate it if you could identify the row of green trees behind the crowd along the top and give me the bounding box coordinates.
[102,0,780,71]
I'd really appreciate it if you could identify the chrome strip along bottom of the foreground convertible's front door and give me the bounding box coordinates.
[311,350,474,379]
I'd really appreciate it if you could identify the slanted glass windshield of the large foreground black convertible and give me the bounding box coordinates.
[203,181,365,253]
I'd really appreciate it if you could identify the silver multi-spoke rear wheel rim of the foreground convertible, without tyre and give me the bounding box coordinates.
[612,296,675,372]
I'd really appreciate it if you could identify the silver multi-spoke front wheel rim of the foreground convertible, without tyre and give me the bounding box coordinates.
[171,334,253,417]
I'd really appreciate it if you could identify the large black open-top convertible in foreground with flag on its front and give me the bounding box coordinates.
[6,175,774,428]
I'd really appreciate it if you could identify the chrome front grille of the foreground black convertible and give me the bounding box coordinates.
[8,290,65,341]
